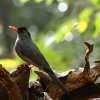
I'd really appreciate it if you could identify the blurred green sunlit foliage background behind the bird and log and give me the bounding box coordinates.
[0,0,100,74]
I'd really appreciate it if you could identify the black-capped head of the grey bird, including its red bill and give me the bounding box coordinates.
[9,26,30,38]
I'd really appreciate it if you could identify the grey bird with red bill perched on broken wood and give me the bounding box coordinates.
[9,26,68,93]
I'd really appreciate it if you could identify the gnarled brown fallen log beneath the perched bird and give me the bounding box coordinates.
[0,42,100,100]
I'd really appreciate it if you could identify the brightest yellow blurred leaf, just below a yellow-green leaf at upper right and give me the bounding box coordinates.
[78,20,88,33]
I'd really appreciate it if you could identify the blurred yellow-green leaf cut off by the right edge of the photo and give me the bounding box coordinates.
[93,12,100,37]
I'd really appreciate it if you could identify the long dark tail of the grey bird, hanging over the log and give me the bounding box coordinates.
[45,69,68,93]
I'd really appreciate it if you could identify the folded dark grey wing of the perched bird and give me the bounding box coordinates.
[16,41,49,67]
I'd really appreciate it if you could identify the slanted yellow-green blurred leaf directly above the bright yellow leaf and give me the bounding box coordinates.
[79,8,93,19]
